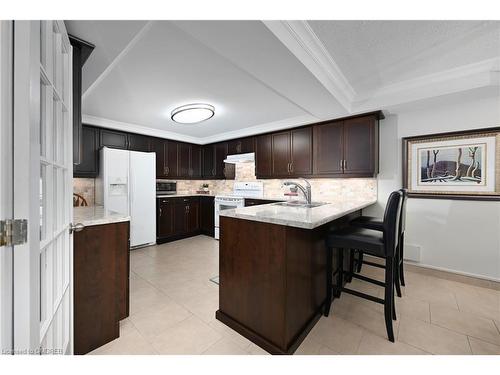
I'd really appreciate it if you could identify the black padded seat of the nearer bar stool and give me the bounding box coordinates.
[326,227,385,256]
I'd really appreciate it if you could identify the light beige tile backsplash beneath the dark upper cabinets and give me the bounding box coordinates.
[73,163,377,205]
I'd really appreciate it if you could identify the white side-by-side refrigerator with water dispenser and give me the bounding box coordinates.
[96,147,156,247]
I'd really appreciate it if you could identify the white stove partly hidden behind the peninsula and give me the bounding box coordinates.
[215,181,264,240]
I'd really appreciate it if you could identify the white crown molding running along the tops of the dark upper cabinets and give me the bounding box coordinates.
[82,115,319,145]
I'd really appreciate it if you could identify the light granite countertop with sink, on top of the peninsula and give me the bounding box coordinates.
[220,199,377,229]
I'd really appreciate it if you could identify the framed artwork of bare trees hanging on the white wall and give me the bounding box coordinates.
[403,128,500,200]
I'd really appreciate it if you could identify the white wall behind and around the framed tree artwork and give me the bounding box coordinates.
[364,91,500,281]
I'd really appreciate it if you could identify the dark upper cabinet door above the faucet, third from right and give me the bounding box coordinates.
[290,127,312,177]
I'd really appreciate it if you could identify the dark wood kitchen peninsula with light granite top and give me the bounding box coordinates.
[216,198,376,354]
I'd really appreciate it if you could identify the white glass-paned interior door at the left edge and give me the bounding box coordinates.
[13,21,73,354]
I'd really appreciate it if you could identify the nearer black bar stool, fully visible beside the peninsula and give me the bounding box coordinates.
[324,191,403,342]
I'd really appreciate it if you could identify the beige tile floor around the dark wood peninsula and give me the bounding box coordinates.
[91,236,500,355]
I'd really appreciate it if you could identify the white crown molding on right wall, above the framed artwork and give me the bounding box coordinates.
[352,58,500,112]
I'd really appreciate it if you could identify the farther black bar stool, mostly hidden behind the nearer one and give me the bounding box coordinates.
[349,189,408,297]
